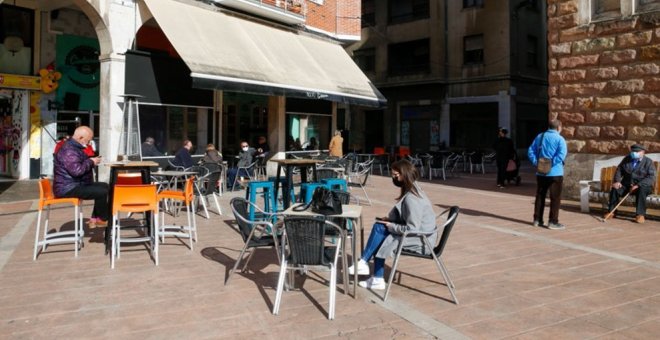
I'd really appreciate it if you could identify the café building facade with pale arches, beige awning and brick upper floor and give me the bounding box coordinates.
[0,0,378,179]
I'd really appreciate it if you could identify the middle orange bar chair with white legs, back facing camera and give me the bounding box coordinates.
[110,184,158,269]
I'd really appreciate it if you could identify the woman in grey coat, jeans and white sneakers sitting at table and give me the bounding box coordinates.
[348,159,437,290]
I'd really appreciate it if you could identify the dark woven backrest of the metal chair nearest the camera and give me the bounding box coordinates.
[284,216,328,266]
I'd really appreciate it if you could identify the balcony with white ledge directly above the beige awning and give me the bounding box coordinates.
[212,0,307,25]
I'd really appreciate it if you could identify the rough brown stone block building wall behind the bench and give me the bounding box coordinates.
[548,0,660,197]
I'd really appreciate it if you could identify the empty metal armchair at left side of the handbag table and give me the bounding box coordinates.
[225,197,280,285]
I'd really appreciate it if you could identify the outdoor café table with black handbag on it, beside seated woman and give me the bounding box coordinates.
[282,203,364,299]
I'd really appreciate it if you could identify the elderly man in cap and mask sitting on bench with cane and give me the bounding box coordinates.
[606,144,656,223]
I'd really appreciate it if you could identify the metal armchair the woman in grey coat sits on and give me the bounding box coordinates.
[383,206,460,304]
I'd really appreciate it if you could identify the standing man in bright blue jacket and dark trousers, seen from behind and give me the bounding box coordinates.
[527,119,568,230]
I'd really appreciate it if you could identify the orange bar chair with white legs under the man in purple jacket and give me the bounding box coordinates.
[32,178,85,261]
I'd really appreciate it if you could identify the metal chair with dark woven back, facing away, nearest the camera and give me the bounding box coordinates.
[273,217,341,320]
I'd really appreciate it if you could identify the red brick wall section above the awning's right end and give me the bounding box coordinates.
[306,0,361,38]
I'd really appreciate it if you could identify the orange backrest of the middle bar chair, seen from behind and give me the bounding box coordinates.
[112,184,158,215]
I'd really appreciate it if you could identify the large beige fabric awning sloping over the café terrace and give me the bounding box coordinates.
[145,0,387,107]
